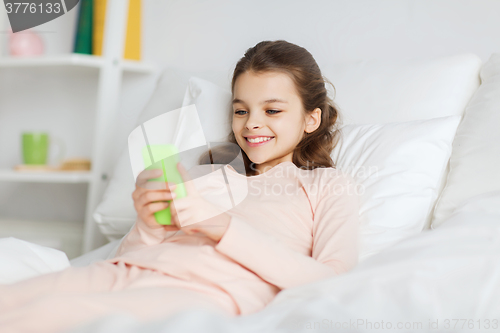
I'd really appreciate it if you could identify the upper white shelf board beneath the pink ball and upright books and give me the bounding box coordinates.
[0,53,156,74]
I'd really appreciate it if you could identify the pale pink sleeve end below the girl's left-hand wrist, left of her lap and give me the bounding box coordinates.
[115,217,177,257]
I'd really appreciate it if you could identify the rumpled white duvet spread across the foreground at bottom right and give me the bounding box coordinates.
[0,209,500,333]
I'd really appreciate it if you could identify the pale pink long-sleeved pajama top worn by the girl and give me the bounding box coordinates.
[108,162,359,315]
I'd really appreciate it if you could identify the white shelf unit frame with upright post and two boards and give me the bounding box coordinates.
[0,0,158,253]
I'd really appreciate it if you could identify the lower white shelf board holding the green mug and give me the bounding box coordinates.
[0,169,92,183]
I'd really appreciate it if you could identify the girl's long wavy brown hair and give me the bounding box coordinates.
[199,40,341,176]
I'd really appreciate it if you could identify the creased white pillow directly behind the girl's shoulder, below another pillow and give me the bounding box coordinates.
[332,116,461,261]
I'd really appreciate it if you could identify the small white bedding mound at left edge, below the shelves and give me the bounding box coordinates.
[0,237,70,284]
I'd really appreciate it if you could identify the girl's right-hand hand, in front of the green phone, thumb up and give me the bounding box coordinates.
[170,163,231,242]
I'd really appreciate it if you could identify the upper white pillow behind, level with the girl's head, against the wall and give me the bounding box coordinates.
[321,54,481,125]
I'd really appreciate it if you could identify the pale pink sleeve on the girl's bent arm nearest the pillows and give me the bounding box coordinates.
[215,171,359,289]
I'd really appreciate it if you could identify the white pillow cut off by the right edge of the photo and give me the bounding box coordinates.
[431,53,500,228]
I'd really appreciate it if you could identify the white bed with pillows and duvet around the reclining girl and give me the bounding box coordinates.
[0,3,500,333]
